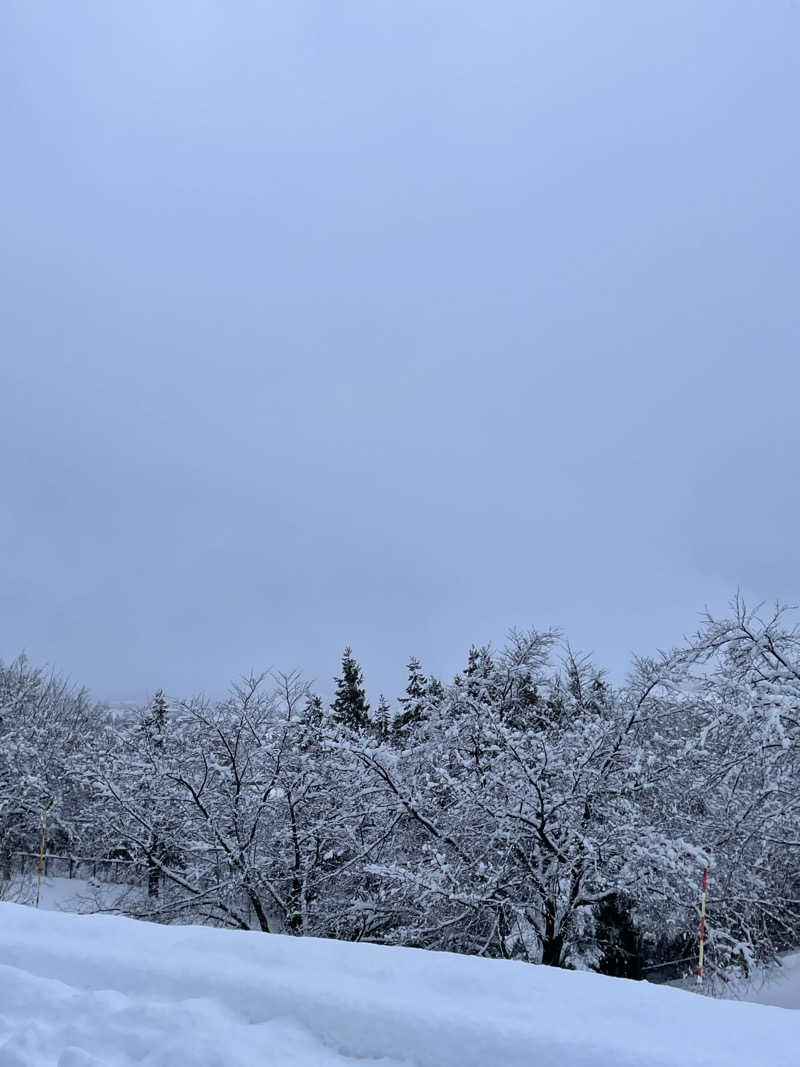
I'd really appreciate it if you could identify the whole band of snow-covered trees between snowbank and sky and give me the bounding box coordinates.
[0,600,800,976]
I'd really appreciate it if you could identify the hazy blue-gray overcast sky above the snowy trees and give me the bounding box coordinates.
[0,0,800,699]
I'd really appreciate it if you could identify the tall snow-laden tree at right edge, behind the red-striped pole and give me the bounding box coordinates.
[673,596,800,968]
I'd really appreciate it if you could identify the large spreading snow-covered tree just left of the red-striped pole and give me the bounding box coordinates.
[347,633,693,965]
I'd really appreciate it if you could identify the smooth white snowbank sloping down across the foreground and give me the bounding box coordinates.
[0,904,800,1067]
